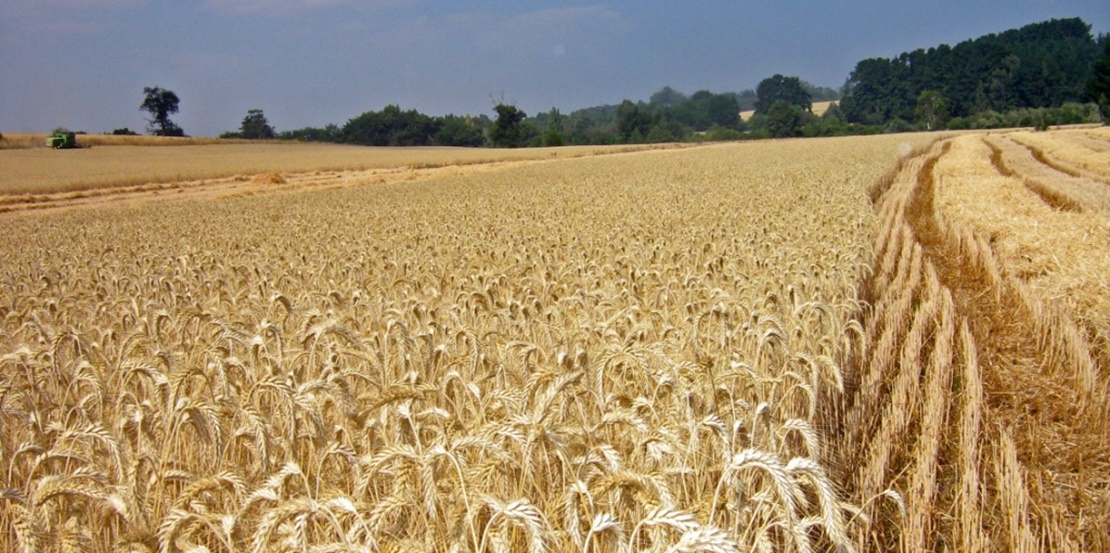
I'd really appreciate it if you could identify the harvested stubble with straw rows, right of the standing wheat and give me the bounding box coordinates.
[831,129,1110,551]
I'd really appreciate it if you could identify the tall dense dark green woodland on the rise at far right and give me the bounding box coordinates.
[840,18,1107,124]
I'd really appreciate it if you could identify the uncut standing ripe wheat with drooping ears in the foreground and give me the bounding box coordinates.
[0,135,936,552]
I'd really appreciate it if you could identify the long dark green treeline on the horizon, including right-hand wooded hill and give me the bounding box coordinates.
[270,18,1110,148]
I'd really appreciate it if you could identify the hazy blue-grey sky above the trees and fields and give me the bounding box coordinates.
[0,0,1110,137]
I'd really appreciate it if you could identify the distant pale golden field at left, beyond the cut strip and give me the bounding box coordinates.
[0,134,660,195]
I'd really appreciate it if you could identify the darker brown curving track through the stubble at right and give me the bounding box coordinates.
[874,141,1110,551]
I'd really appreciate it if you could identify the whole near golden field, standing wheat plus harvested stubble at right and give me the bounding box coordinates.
[0,129,1110,553]
